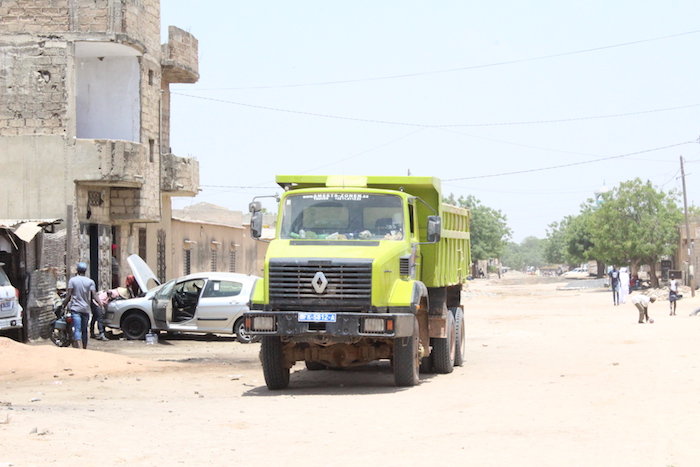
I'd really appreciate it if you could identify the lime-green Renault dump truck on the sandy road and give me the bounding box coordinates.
[245,175,471,389]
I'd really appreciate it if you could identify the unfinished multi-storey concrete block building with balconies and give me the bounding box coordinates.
[0,0,199,336]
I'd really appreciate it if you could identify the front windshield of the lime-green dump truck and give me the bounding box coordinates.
[280,193,404,240]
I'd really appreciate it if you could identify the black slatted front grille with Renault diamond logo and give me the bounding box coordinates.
[270,259,372,311]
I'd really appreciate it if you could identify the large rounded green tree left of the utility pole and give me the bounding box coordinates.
[589,178,683,287]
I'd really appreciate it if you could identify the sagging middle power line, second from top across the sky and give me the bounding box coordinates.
[171,92,700,128]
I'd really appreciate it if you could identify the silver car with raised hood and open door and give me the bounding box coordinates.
[104,255,260,343]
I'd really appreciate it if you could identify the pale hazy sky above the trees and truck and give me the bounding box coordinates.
[161,0,700,242]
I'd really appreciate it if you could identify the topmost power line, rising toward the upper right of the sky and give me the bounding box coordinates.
[172,30,700,91]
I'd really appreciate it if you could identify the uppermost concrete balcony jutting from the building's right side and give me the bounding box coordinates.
[161,26,199,83]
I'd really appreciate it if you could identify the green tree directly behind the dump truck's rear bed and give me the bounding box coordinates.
[444,193,511,262]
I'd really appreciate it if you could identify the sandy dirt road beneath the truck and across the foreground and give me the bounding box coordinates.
[0,275,700,467]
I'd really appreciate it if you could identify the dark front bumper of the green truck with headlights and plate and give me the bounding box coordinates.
[243,311,416,338]
